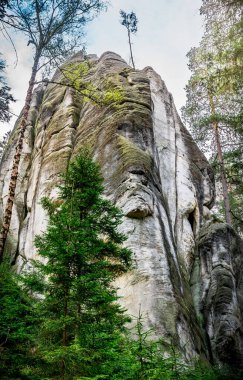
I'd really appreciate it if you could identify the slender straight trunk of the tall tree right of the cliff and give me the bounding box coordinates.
[209,95,232,225]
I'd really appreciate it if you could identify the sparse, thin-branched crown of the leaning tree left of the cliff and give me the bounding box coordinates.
[2,0,106,73]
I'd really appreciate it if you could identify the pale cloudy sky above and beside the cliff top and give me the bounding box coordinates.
[0,0,203,137]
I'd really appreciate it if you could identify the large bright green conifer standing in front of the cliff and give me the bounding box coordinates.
[27,153,130,379]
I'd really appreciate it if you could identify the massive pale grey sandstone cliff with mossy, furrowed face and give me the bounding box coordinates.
[1,52,243,365]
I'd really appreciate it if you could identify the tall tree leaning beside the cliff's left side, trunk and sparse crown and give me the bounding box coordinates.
[0,0,109,261]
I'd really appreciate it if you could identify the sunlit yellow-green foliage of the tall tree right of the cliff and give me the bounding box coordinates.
[182,0,243,232]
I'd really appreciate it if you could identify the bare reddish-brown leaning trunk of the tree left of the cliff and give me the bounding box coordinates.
[0,50,41,263]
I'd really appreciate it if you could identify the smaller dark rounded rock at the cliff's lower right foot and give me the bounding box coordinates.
[191,223,243,368]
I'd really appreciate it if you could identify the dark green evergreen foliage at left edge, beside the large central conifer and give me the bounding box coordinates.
[0,263,36,380]
